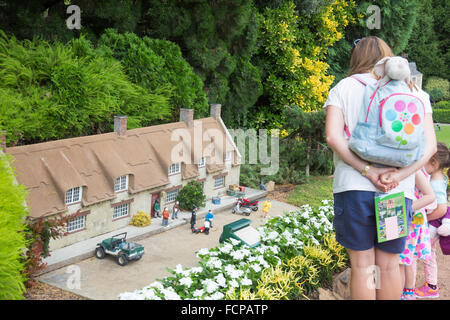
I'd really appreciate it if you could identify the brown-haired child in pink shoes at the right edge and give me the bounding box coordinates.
[415,142,450,299]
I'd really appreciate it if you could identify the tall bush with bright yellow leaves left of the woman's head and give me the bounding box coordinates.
[255,0,356,126]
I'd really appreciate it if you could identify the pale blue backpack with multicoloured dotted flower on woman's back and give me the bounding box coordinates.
[347,75,425,167]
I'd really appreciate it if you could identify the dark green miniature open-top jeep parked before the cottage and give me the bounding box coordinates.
[95,232,144,266]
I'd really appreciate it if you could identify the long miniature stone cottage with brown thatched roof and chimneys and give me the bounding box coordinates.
[6,104,240,250]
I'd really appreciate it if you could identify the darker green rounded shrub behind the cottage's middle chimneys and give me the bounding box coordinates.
[98,29,208,121]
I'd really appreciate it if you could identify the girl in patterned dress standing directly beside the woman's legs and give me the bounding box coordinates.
[400,170,434,300]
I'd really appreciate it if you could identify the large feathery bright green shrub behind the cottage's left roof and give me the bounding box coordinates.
[0,32,170,144]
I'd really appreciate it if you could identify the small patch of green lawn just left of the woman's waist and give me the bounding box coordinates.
[286,176,333,207]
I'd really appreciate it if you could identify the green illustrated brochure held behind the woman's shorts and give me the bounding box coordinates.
[375,192,408,242]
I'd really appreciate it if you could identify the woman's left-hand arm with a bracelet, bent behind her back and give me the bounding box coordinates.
[325,105,398,192]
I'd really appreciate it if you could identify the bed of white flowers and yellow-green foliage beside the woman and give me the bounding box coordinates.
[119,200,346,300]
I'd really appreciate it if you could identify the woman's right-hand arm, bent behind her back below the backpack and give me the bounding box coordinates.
[380,113,437,183]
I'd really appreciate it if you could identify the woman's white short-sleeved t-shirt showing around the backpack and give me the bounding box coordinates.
[323,73,432,199]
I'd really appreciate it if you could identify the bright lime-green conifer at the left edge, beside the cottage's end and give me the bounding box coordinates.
[0,153,28,300]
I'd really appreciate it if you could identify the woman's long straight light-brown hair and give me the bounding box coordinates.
[348,36,418,91]
